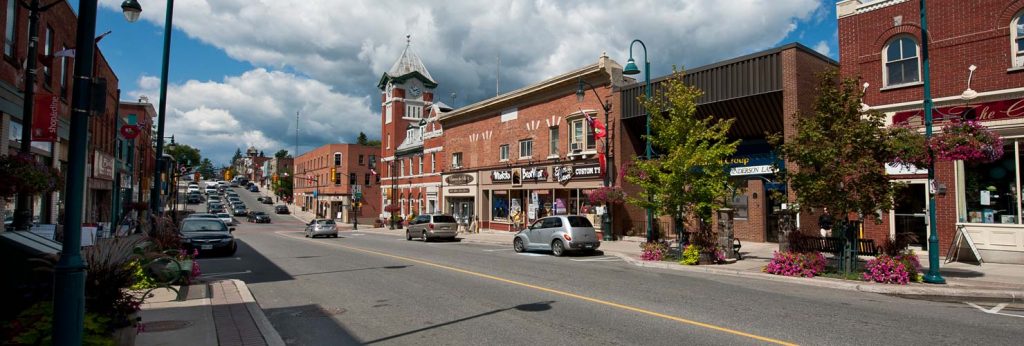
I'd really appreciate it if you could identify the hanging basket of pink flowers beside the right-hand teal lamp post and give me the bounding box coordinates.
[928,121,1002,164]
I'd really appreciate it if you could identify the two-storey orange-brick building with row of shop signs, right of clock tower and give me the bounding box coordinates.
[439,56,624,230]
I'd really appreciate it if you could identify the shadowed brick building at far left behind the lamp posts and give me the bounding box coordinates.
[0,0,118,223]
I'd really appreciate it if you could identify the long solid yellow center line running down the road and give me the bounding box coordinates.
[278,229,797,345]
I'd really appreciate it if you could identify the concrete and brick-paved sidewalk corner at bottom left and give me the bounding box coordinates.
[135,279,285,346]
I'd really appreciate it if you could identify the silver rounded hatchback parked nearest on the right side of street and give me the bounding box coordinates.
[512,215,601,256]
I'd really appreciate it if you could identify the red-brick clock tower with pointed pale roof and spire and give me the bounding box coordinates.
[377,35,437,220]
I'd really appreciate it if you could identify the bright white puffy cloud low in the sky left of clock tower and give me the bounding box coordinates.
[128,69,380,164]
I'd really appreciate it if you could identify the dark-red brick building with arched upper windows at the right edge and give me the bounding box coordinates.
[836,0,1024,263]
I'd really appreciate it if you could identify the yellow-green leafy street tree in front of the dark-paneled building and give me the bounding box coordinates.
[626,69,739,239]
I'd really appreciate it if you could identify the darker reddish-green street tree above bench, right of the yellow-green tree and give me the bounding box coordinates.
[769,70,899,229]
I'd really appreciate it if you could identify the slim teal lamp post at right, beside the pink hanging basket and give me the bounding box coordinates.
[921,0,946,284]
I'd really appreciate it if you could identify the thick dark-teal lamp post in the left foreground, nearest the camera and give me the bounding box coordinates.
[51,0,96,346]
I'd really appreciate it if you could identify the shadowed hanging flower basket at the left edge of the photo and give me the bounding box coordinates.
[0,155,63,197]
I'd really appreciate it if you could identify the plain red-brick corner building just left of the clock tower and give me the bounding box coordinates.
[293,144,381,223]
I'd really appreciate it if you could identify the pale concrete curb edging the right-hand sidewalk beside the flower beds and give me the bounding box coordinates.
[608,252,1024,301]
